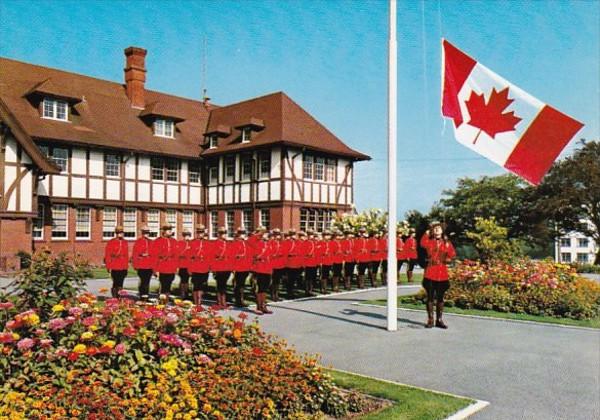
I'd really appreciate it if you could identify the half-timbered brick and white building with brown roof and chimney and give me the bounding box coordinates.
[0,47,369,271]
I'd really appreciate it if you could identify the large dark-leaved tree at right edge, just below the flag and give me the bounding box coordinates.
[531,140,600,265]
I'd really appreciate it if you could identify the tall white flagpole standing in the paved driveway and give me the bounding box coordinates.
[387,0,398,331]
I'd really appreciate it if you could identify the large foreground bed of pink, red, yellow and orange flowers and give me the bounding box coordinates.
[0,294,362,420]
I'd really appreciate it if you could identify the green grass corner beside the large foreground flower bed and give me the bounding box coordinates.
[327,369,475,420]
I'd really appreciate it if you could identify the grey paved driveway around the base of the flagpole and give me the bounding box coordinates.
[253,288,600,420]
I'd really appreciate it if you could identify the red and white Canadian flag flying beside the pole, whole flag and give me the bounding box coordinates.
[442,40,583,185]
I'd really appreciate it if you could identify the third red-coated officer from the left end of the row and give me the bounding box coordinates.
[152,225,179,301]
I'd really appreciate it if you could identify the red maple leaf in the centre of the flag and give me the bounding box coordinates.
[465,87,521,144]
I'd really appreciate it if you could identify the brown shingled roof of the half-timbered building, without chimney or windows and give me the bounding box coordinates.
[0,58,369,164]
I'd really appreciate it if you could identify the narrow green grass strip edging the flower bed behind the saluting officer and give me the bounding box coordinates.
[363,296,600,328]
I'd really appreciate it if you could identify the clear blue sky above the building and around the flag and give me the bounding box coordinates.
[0,0,600,217]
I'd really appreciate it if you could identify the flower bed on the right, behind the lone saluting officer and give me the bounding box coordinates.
[415,259,600,319]
